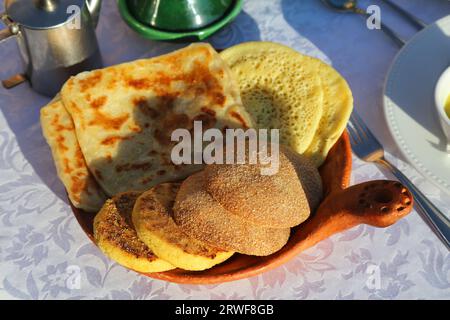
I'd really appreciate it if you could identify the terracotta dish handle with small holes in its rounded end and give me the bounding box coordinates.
[296,180,413,250]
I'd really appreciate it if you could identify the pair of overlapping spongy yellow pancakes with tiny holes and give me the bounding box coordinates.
[221,42,353,167]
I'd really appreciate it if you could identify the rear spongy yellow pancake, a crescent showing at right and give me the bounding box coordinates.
[304,61,353,167]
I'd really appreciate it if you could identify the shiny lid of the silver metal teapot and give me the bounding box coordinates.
[5,0,86,29]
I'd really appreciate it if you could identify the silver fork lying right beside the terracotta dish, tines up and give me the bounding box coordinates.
[347,111,450,250]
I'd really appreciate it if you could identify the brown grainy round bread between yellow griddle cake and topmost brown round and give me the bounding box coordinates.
[174,171,290,256]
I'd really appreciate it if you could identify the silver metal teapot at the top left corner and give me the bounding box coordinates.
[0,0,102,96]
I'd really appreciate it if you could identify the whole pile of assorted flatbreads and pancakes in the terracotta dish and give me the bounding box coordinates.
[41,42,353,272]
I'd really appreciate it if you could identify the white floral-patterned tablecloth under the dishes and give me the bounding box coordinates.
[0,0,450,299]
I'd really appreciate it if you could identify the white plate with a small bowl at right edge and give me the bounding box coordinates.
[383,16,450,194]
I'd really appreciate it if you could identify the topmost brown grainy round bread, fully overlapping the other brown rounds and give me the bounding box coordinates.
[204,146,311,228]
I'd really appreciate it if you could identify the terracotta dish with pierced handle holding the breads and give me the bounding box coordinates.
[72,132,413,284]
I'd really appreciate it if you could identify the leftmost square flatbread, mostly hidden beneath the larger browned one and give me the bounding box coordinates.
[41,96,106,212]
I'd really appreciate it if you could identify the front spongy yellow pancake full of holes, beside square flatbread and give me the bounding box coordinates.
[220,42,323,153]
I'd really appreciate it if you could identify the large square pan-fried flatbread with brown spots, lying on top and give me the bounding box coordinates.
[62,44,252,195]
